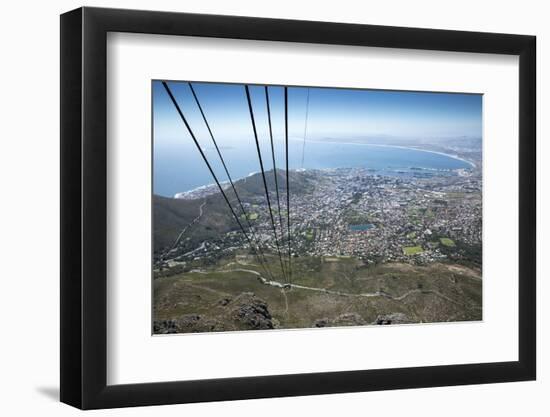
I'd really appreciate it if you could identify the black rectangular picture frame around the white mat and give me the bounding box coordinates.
[60,7,536,409]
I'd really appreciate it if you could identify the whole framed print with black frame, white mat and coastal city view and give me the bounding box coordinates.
[61,8,536,409]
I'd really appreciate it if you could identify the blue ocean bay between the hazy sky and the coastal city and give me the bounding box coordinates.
[153,140,470,197]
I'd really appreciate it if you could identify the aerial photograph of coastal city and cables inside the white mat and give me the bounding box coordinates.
[151,80,483,335]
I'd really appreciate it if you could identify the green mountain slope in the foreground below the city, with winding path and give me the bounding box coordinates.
[153,255,481,331]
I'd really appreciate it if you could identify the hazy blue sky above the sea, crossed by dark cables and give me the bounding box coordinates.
[153,81,482,147]
